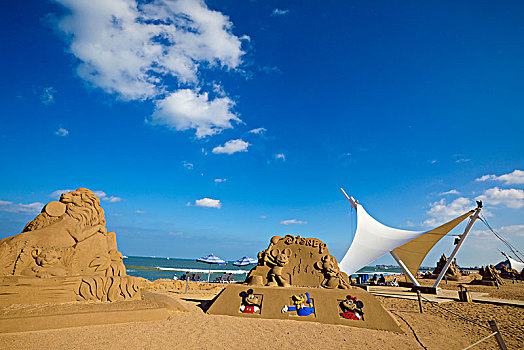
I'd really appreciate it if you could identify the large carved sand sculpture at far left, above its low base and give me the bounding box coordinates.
[0,188,140,305]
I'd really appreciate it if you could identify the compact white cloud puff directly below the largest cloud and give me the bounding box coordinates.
[150,89,241,138]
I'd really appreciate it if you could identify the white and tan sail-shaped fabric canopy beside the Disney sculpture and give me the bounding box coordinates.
[339,203,471,275]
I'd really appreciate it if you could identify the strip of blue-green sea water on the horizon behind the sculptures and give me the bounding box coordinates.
[124,256,408,281]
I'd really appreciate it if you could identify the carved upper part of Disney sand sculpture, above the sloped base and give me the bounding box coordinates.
[246,235,350,289]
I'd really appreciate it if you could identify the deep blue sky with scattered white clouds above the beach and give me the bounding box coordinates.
[0,0,524,265]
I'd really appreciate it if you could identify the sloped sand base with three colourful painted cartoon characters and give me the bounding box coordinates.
[207,284,402,333]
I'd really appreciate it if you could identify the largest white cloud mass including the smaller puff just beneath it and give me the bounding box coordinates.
[56,0,249,137]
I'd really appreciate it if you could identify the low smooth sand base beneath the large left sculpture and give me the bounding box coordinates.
[0,291,187,333]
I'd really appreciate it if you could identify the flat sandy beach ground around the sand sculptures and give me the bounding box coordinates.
[0,280,524,349]
